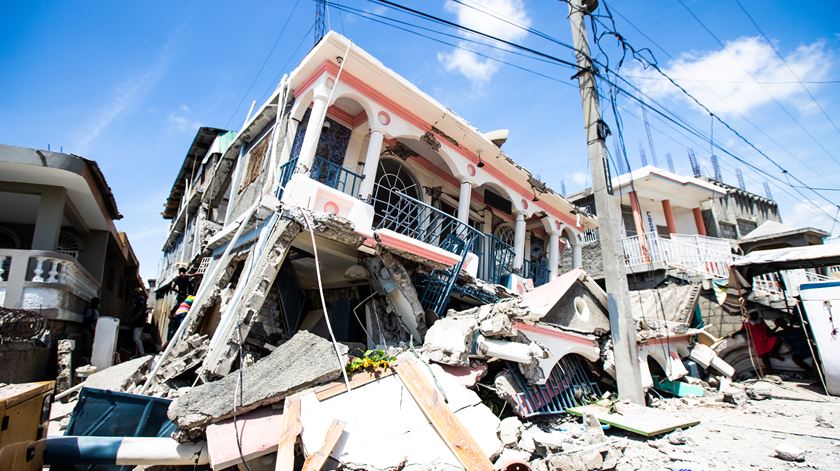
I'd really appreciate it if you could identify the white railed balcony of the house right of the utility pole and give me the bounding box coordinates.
[621,232,735,278]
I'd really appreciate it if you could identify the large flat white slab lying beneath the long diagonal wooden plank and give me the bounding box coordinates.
[301,358,501,469]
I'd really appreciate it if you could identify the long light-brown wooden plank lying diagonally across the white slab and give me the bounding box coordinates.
[394,358,493,471]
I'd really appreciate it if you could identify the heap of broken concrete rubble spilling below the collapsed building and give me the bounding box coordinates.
[46,209,761,470]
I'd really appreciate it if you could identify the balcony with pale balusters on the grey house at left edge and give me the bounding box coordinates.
[0,249,100,321]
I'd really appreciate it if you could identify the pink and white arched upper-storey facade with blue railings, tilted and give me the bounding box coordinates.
[217,32,594,284]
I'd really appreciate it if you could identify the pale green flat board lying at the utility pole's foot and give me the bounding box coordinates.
[566,404,700,437]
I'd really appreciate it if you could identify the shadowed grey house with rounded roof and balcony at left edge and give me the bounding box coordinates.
[0,145,143,379]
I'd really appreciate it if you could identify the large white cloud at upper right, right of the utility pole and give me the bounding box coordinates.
[633,37,832,116]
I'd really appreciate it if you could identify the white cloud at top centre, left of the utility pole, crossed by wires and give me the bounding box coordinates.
[437,0,531,85]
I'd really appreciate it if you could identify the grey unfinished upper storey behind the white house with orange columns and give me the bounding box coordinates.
[702,178,782,240]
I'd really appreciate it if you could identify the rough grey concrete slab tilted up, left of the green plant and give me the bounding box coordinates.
[168,331,343,430]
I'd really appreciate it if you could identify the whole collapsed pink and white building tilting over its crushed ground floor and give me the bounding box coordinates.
[154,33,594,375]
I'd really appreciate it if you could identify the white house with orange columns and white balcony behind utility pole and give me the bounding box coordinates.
[563,166,732,284]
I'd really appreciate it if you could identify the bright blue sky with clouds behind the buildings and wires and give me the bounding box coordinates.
[0,0,840,277]
